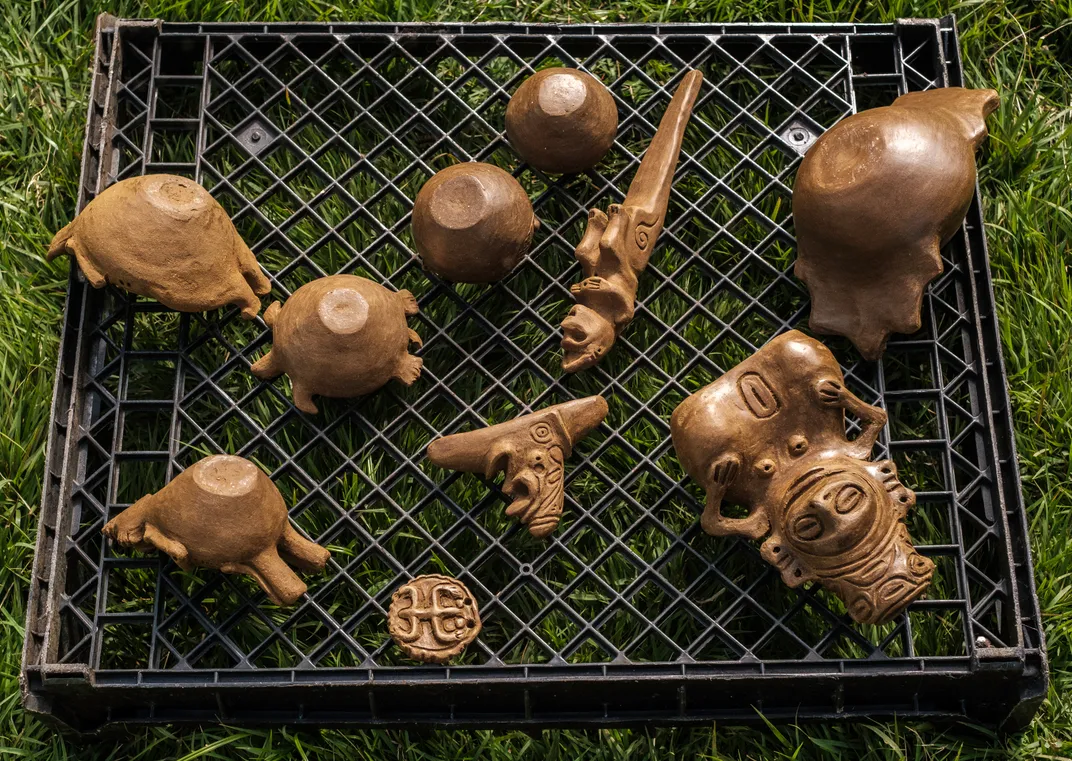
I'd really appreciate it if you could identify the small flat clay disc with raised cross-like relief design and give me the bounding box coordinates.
[387,573,480,663]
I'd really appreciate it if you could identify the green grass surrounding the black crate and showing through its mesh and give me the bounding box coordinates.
[0,0,1072,760]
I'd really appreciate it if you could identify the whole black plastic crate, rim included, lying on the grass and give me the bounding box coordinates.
[24,17,1047,730]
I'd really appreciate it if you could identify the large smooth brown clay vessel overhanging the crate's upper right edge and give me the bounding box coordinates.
[793,87,998,360]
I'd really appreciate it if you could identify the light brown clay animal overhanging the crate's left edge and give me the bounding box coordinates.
[47,175,271,319]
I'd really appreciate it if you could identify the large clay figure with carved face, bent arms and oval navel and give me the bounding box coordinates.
[670,330,935,624]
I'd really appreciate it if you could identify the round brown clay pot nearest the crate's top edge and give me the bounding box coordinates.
[506,69,617,174]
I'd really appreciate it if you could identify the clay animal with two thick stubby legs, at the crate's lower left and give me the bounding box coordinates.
[103,454,330,606]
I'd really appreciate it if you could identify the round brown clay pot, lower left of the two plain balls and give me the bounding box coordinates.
[413,162,539,283]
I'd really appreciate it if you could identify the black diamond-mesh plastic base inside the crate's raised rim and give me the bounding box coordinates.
[50,23,1022,671]
